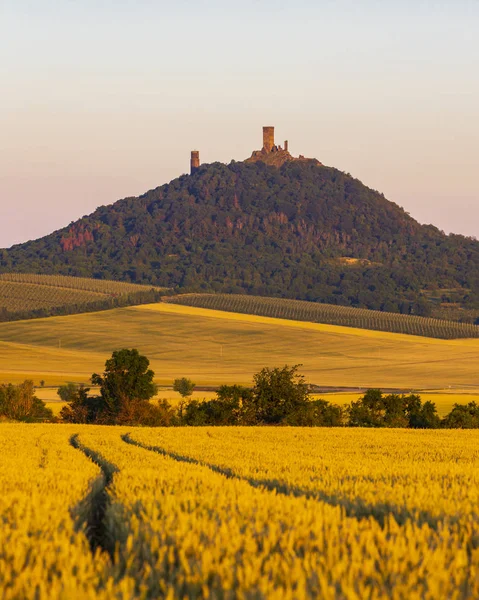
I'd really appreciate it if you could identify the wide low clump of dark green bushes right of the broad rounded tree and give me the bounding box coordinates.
[348,389,441,429]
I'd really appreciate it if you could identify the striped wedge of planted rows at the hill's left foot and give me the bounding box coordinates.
[0,273,161,321]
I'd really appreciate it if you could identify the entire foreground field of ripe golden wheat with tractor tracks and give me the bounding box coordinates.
[0,424,479,600]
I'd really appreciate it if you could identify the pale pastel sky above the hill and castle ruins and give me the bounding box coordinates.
[0,0,479,248]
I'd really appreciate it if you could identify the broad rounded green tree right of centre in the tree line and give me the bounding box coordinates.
[252,365,311,425]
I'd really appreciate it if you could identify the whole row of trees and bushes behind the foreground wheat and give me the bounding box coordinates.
[0,349,479,429]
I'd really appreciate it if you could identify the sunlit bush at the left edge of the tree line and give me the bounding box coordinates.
[0,380,53,423]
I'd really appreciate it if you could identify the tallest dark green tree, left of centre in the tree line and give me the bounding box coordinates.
[91,348,157,422]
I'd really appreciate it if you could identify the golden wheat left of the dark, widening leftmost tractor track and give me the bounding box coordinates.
[0,424,120,600]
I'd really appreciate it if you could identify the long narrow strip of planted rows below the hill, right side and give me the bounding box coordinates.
[168,294,479,340]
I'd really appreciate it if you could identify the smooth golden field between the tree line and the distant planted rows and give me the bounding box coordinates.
[0,303,479,391]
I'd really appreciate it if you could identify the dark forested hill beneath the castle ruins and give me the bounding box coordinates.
[0,161,479,314]
